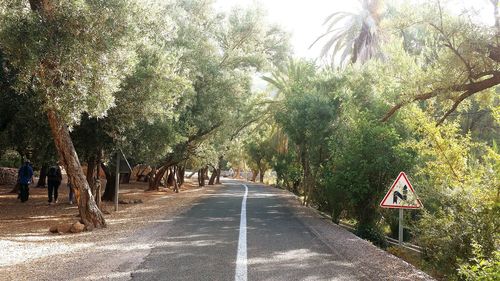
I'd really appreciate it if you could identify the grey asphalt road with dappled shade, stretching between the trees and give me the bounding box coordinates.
[131,181,369,281]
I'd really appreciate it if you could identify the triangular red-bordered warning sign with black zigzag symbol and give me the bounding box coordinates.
[380,172,422,209]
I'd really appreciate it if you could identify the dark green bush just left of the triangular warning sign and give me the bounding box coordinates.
[324,112,411,237]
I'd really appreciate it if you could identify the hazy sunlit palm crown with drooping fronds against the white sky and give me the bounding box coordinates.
[310,0,384,63]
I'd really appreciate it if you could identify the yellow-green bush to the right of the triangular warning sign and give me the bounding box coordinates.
[403,109,500,279]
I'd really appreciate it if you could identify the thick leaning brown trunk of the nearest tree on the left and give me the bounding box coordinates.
[47,110,106,230]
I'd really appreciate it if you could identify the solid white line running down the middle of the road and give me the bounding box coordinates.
[234,185,248,281]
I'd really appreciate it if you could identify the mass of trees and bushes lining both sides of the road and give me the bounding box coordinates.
[0,0,500,280]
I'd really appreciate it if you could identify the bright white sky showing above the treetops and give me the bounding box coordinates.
[216,0,493,59]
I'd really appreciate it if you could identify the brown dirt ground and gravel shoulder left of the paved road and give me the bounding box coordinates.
[0,177,220,280]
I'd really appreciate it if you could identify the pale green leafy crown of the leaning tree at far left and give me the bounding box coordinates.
[0,0,137,125]
